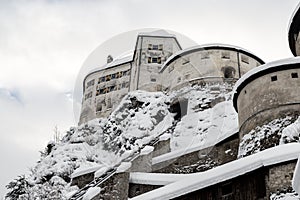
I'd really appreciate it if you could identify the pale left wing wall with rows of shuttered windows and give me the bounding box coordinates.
[79,63,131,124]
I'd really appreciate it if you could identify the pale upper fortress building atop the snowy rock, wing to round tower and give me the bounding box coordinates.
[79,30,264,124]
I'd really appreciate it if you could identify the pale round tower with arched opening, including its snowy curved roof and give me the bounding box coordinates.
[160,44,264,91]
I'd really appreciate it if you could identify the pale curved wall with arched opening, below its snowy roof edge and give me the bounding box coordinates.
[161,49,260,90]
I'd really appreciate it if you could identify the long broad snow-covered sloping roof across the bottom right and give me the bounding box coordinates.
[131,143,300,200]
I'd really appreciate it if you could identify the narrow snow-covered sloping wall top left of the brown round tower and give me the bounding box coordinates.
[152,128,238,164]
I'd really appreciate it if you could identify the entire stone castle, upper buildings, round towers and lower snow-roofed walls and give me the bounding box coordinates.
[70,1,300,200]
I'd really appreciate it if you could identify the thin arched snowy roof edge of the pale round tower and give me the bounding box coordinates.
[160,43,265,72]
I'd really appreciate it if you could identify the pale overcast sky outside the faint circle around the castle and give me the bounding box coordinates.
[0,0,299,195]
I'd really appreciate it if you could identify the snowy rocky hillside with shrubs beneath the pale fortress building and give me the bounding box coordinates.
[7,84,237,199]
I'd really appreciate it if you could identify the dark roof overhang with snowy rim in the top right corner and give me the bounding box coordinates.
[288,3,300,56]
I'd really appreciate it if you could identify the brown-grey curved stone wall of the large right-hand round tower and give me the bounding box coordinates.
[237,69,300,138]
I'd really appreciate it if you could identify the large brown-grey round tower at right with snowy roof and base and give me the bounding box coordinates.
[233,57,300,155]
